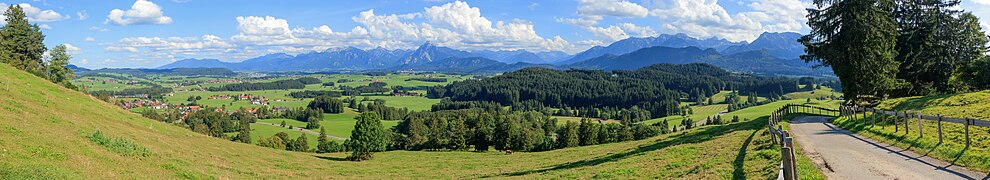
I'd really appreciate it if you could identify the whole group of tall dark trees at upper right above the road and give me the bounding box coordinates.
[799,0,990,100]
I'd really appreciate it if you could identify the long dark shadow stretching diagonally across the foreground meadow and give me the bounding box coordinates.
[481,116,767,178]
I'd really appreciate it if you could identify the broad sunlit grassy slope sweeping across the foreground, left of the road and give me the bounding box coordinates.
[0,64,820,179]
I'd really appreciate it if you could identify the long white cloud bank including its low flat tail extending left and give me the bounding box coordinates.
[101,1,581,65]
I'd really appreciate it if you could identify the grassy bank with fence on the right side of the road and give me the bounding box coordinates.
[833,91,990,172]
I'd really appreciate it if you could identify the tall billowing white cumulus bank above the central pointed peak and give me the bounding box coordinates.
[231,1,573,51]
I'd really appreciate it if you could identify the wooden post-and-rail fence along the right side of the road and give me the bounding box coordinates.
[839,106,990,147]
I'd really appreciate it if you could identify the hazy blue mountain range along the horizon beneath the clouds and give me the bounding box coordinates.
[158,32,831,76]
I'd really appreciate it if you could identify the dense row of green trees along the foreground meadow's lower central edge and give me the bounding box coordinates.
[393,109,664,151]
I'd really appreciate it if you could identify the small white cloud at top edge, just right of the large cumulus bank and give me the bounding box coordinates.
[578,0,649,18]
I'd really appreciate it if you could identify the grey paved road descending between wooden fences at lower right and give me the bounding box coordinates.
[790,116,987,179]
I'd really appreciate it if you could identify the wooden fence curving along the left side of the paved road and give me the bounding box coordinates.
[767,104,839,180]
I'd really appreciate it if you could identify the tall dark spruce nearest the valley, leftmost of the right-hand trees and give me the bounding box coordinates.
[798,0,906,100]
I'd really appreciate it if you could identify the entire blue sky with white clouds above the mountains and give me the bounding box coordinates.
[0,0,990,68]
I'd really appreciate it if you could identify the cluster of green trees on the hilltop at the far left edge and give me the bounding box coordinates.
[0,4,78,89]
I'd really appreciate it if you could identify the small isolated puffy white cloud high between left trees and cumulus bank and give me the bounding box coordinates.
[106,0,172,26]
